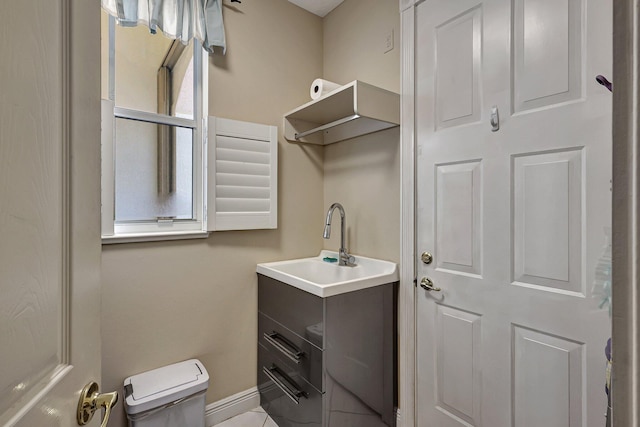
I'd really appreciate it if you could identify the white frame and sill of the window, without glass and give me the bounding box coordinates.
[101,16,209,244]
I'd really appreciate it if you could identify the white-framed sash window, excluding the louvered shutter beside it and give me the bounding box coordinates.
[102,12,207,242]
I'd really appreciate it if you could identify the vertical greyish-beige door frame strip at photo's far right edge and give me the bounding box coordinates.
[612,0,640,427]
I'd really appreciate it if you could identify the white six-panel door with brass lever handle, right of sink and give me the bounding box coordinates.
[414,0,612,427]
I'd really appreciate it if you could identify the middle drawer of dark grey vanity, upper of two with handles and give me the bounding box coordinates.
[258,313,324,391]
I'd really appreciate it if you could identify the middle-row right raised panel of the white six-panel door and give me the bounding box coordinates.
[511,149,586,296]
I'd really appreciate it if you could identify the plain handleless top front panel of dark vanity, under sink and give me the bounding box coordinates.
[258,274,324,348]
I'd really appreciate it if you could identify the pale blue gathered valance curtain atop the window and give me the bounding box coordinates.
[101,0,226,54]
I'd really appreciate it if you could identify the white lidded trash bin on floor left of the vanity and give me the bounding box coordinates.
[124,359,209,427]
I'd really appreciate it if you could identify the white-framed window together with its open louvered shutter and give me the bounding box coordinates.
[102,12,278,243]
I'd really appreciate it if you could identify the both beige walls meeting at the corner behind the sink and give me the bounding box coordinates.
[102,0,400,427]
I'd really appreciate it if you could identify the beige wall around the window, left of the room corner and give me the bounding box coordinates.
[101,0,324,427]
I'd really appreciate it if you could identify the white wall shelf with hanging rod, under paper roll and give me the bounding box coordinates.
[284,80,400,145]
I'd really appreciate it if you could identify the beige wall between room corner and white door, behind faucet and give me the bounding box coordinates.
[323,0,400,262]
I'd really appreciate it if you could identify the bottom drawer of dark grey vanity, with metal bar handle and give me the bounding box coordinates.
[258,343,322,427]
